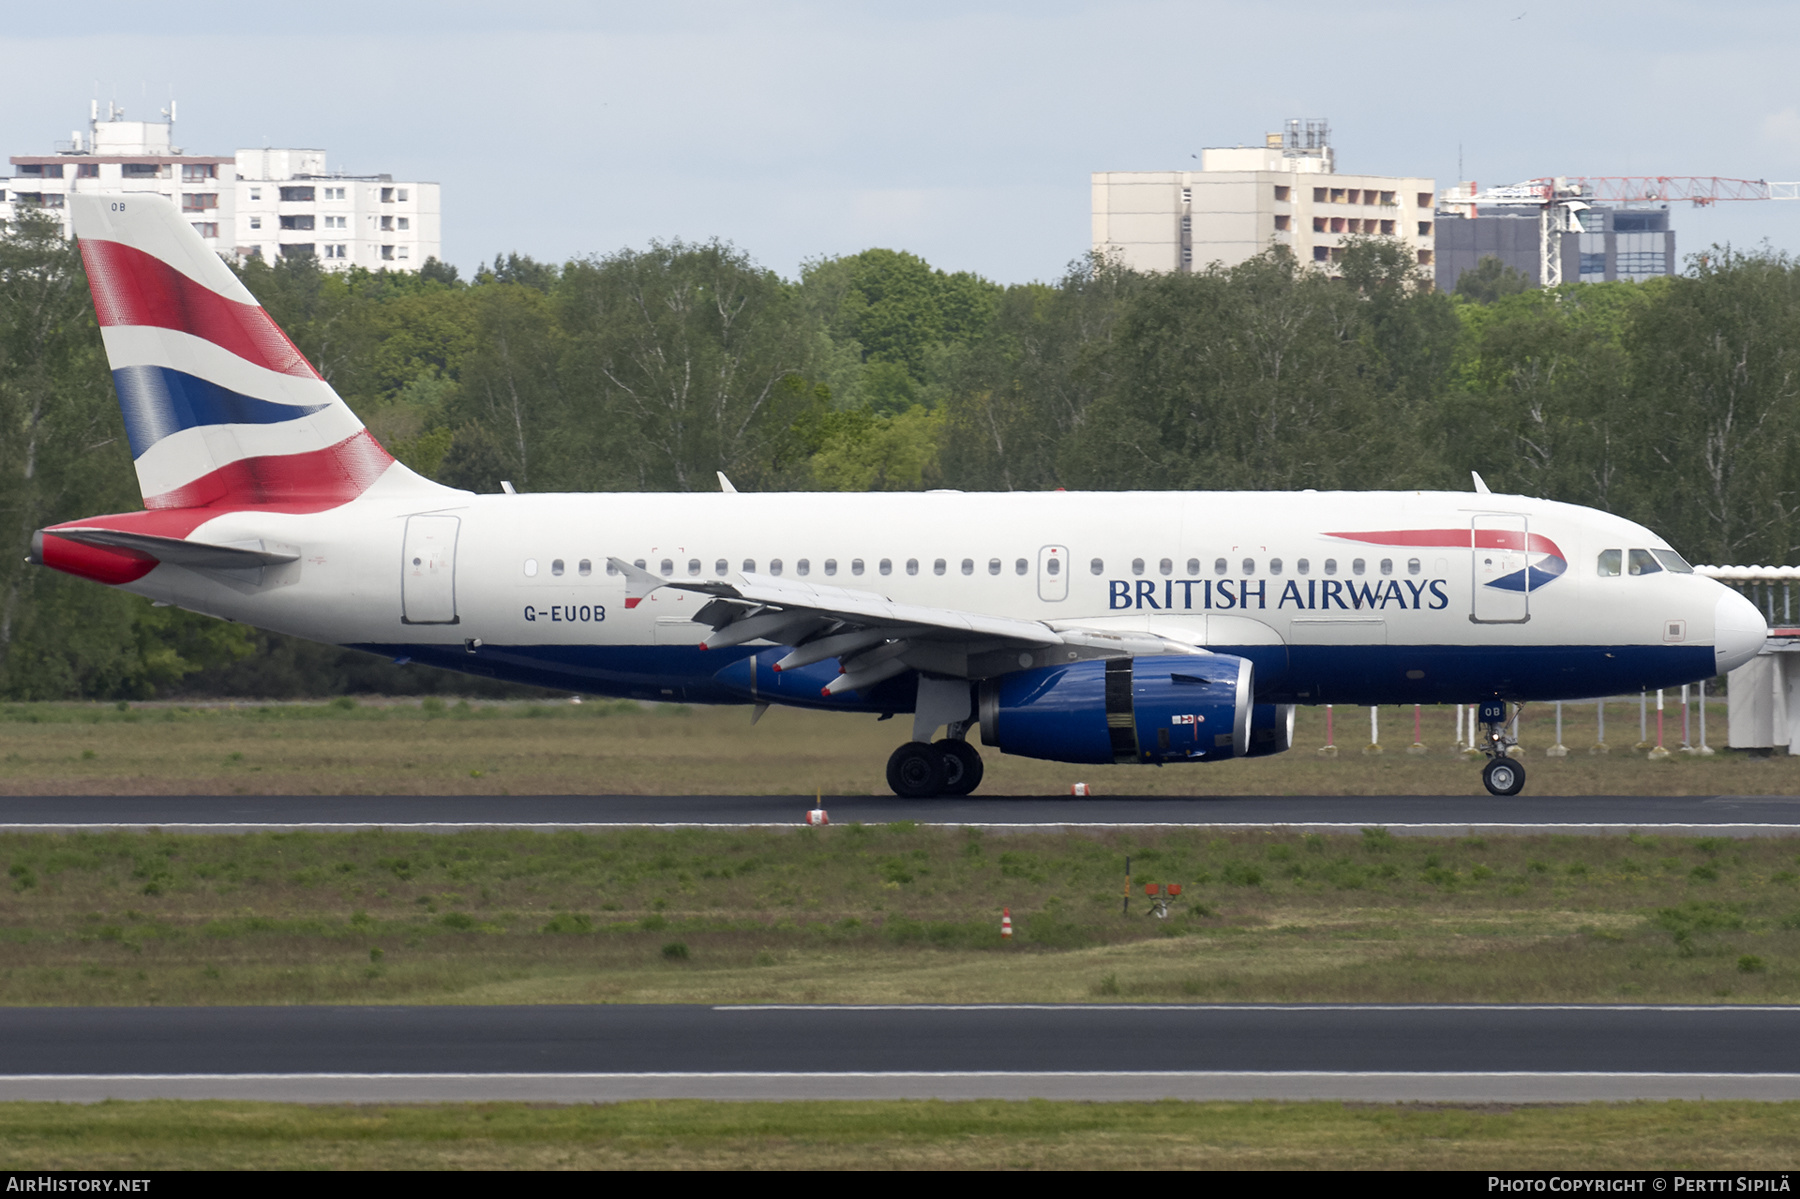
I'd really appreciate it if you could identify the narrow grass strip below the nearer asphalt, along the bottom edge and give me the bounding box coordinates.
[0,1100,1800,1172]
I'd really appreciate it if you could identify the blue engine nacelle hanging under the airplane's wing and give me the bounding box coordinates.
[981,654,1252,763]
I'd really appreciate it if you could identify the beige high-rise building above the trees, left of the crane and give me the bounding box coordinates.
[1093,121,1436,272]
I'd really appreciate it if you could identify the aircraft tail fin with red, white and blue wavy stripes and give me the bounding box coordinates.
[68,194,446,511]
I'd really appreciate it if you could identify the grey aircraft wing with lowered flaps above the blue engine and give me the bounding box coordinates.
[608,558,1204,693]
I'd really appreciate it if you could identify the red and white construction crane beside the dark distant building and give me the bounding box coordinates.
[1444,175,1800,288]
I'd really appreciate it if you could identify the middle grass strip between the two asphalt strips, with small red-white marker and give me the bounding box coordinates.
[0,823,1800,1005]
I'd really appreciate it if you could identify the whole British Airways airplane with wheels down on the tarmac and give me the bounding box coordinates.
[31,194,1768,799]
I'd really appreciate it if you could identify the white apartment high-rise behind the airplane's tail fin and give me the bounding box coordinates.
[0,103,443,270]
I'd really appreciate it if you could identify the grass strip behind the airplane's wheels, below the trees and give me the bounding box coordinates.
[0,699,1778,796]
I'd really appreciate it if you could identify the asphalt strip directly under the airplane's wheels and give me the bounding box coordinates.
[0,794,1800,837]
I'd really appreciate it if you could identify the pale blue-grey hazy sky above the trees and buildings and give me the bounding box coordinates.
[0,0,1800,283]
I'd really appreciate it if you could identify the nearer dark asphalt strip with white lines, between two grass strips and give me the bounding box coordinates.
[0,1005,1800,1102]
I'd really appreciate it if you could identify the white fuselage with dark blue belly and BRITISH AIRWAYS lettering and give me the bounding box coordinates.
[108,486,1762,708]
